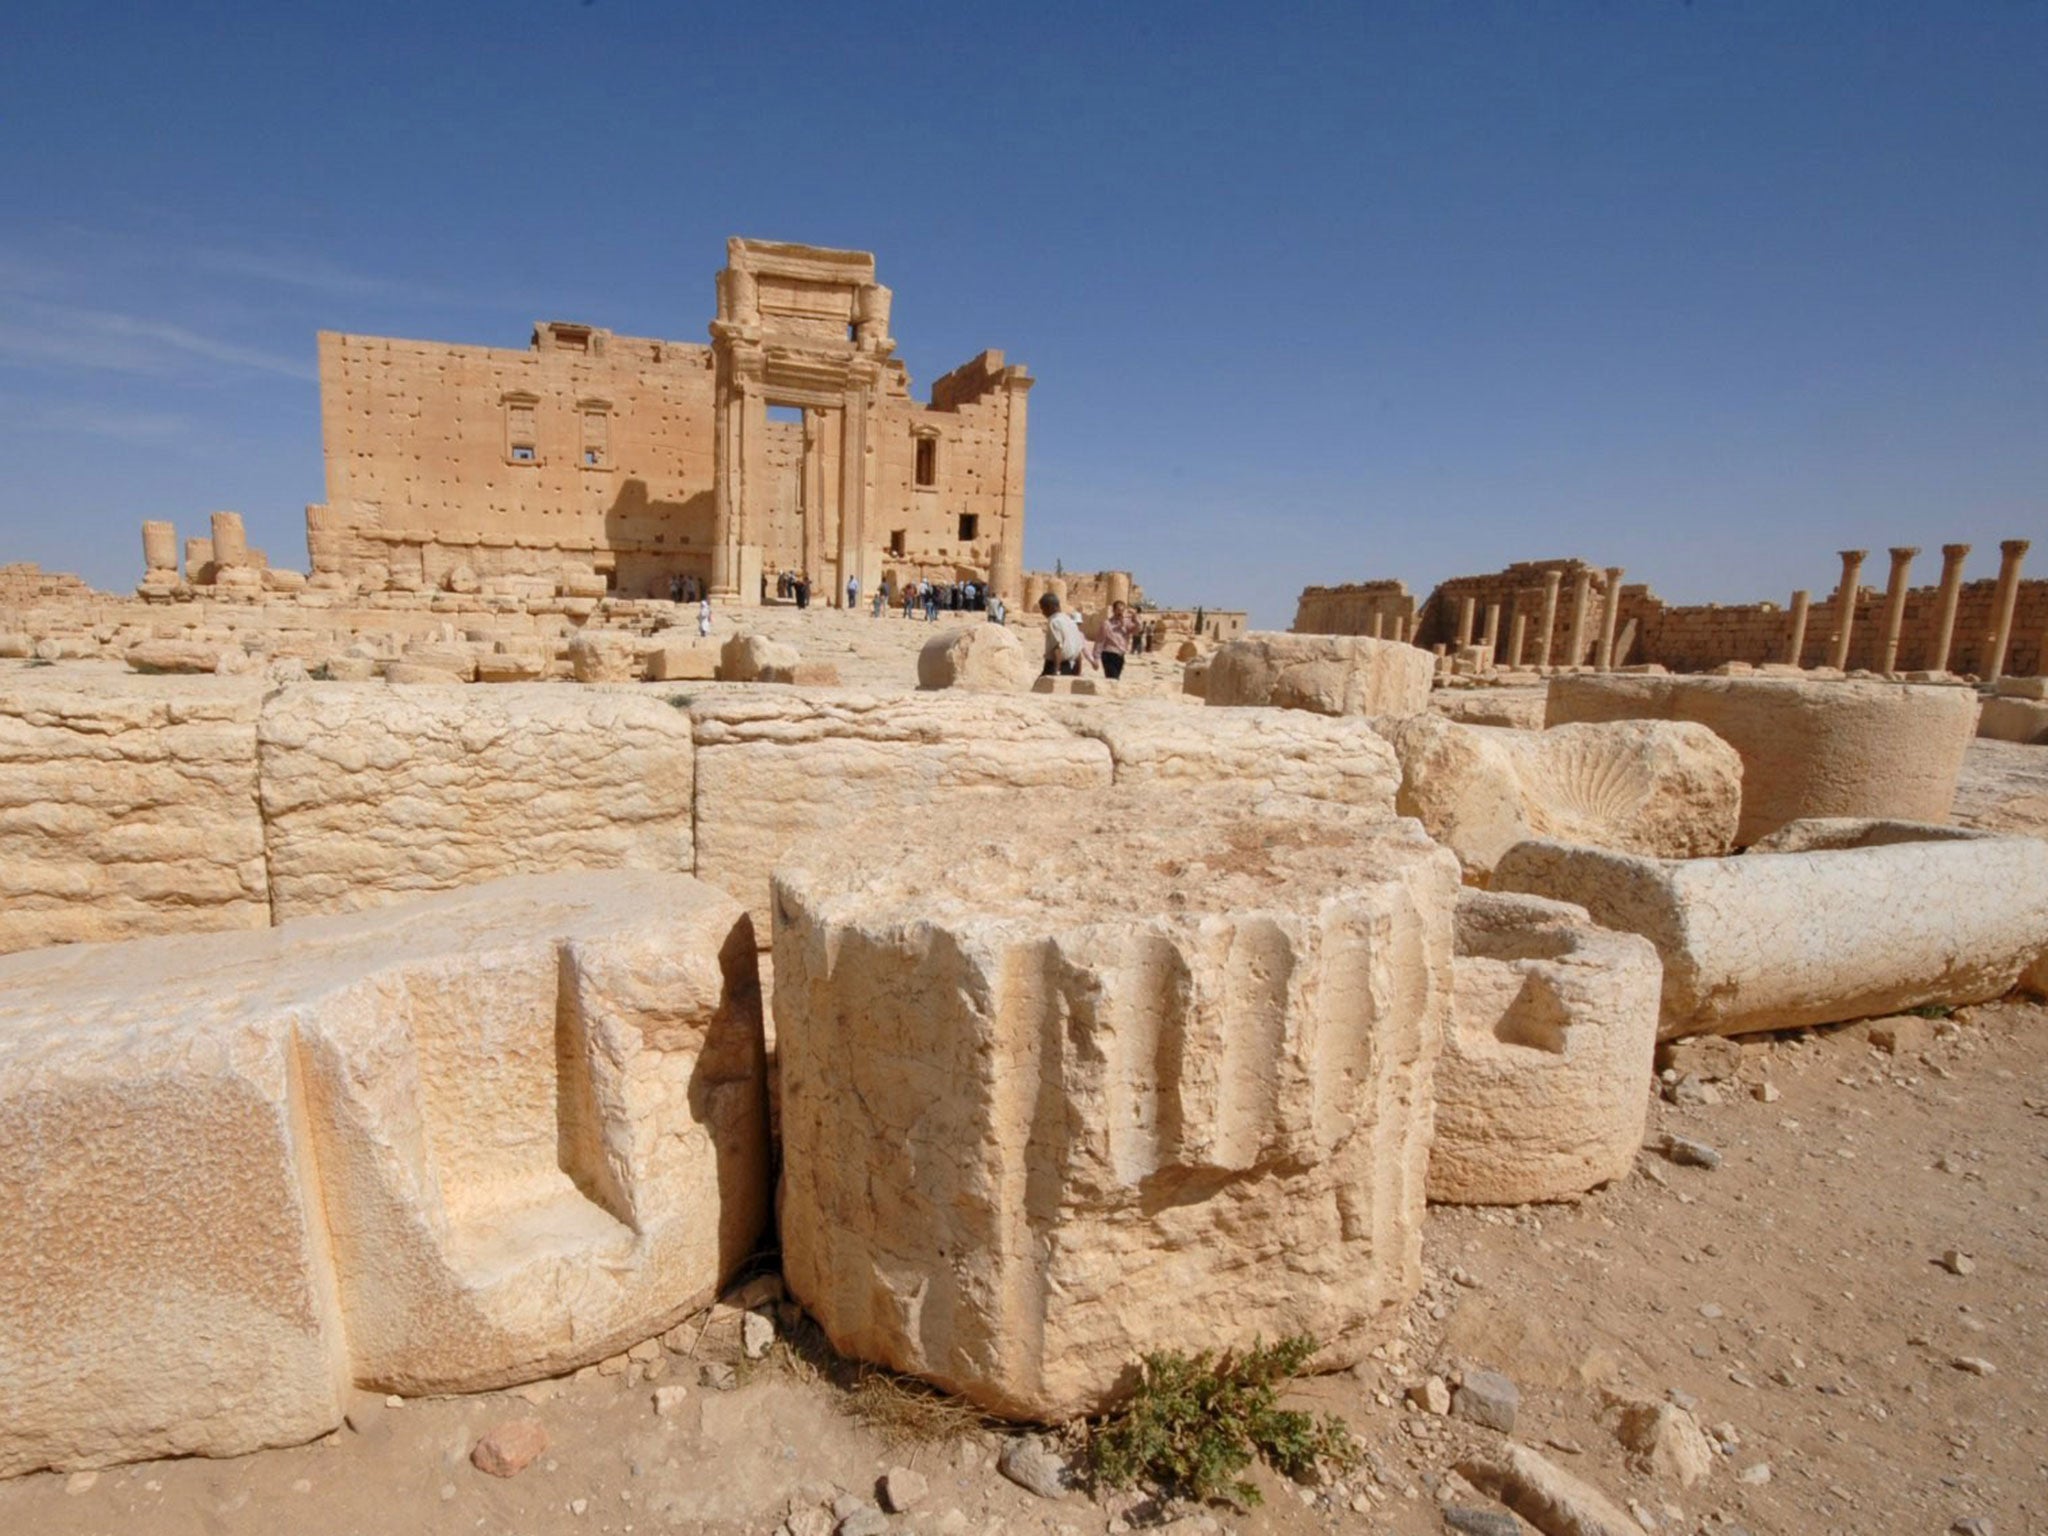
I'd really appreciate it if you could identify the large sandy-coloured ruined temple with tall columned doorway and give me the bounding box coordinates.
[307,238,1032,602]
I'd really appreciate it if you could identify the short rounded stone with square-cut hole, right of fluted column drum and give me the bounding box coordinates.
[1430,891,1663,1204]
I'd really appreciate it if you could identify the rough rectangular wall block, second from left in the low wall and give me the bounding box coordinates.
[258,684,694,922]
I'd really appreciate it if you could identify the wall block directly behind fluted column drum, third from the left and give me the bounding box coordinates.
[688,690,1112,940]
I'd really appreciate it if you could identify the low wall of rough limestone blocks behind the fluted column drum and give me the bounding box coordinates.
[0,674,1399,952]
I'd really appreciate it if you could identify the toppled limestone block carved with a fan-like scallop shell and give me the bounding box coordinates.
[1380,713,1743,885]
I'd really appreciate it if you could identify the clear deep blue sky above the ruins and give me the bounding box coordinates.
[0,0,2048,627]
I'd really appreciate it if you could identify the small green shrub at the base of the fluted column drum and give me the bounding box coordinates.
[1087,1333,1358,1507]
